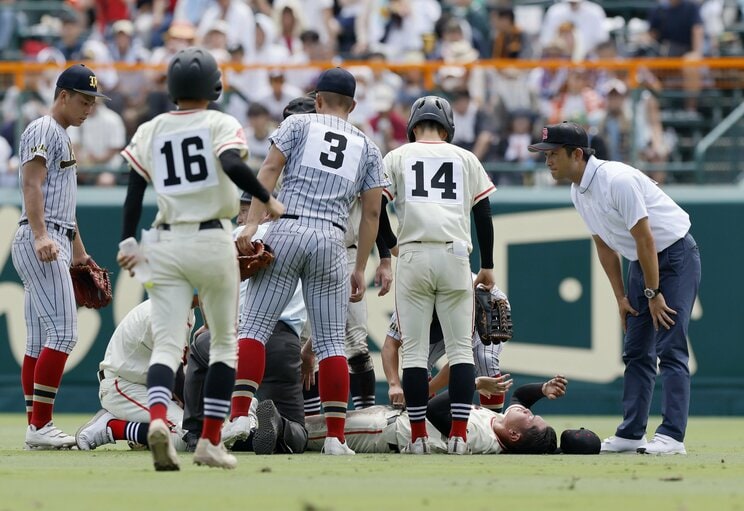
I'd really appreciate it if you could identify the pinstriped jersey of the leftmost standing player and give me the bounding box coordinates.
[19,115,77,229]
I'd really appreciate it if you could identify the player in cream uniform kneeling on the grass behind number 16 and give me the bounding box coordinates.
[75,295,193,451]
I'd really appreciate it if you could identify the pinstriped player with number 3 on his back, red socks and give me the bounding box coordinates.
[232,68,386,455]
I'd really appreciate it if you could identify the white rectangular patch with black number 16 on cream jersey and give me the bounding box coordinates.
[153,130,218,194]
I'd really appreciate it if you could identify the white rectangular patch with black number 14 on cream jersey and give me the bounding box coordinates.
[405,158,463,204]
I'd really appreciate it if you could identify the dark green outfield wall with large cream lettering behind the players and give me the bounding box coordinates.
[0,187,744,415]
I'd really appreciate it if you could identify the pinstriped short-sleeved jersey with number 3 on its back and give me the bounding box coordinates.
[271,114,387,230]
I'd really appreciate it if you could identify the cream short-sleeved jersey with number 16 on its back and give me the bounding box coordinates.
[121,110,248,225]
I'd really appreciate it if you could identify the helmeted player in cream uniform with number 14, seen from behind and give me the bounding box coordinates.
[384,96,495,454]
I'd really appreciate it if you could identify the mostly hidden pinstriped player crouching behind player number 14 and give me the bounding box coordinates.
[382,286,507,412]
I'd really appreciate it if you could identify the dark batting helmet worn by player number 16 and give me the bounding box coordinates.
[168,46,222,101]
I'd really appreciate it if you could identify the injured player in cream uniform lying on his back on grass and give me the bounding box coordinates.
[296,375,568,454]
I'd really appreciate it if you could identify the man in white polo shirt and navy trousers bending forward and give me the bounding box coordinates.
[530,122,700,454]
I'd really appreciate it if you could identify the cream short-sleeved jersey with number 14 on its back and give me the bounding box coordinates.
[384,142,496,251]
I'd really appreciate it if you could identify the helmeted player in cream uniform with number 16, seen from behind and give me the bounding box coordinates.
[118,47,284,470]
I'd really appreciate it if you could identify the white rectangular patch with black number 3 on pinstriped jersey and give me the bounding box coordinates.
[302,122,364,181]
